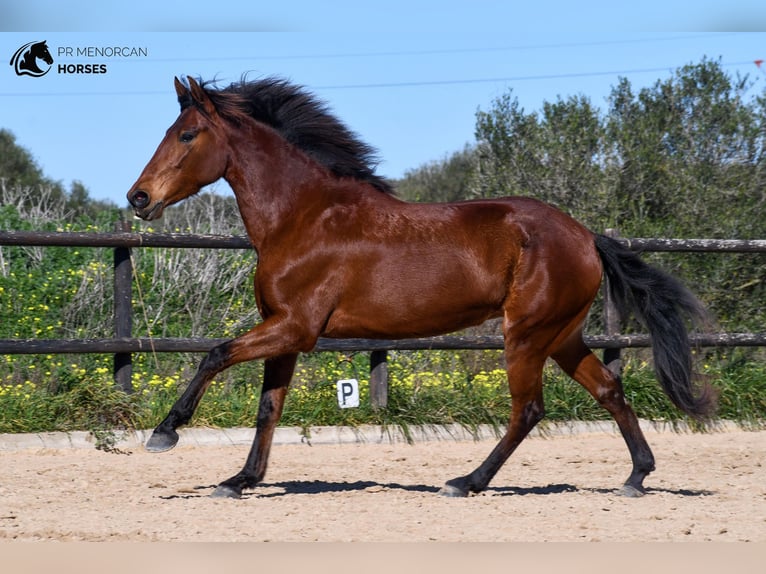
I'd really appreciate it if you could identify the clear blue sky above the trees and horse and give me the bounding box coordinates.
[0,0,766,205]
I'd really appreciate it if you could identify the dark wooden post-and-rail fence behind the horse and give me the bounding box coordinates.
[0,224,766,407]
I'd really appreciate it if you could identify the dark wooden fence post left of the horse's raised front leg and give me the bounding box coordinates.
[114,221,133,393]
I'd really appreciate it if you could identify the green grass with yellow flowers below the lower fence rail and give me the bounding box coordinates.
[0,352,766,433]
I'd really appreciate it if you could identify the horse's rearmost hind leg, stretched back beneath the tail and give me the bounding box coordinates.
[552,338,654,497]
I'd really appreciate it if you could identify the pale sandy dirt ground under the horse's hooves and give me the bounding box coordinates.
[0,429,766,542]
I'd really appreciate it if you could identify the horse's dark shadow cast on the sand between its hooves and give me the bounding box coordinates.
[159,480,715,500]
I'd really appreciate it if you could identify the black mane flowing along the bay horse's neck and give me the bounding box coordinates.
[180,78,394,193]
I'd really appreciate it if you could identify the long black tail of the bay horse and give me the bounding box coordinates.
[595,235,716,417]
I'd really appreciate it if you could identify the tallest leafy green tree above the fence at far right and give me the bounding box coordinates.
[606,60,766,237]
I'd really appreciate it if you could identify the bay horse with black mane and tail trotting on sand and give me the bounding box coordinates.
[127,77,715,498]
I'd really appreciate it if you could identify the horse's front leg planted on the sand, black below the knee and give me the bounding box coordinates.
[212,354,298,498]
